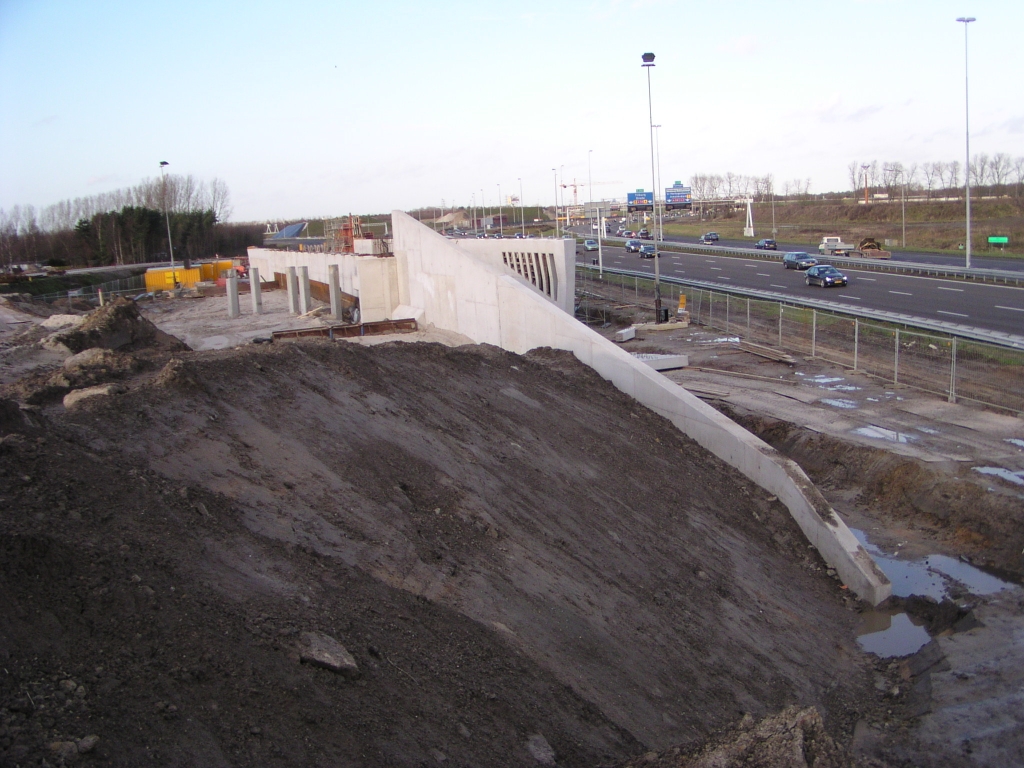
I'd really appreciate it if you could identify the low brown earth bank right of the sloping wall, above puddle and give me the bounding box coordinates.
[722,408,1024,581]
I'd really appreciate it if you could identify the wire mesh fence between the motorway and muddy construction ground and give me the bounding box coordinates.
[577,270,1024,413]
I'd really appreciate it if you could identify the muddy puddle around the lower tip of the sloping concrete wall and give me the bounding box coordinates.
[851,528,1016,658]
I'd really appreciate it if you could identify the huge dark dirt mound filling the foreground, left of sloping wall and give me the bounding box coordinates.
[0,341,878,766]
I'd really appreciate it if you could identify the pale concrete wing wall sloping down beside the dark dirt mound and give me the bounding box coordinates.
[392,211,892,604]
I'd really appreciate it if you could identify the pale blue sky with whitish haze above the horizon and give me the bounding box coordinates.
[0,0,1024,221]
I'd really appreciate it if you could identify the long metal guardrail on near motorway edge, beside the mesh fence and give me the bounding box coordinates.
[577,263,1024,349]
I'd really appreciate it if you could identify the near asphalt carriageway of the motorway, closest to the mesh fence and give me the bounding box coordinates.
[577,246,1024,336]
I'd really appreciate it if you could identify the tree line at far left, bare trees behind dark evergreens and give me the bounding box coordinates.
[0,175,262,268]
